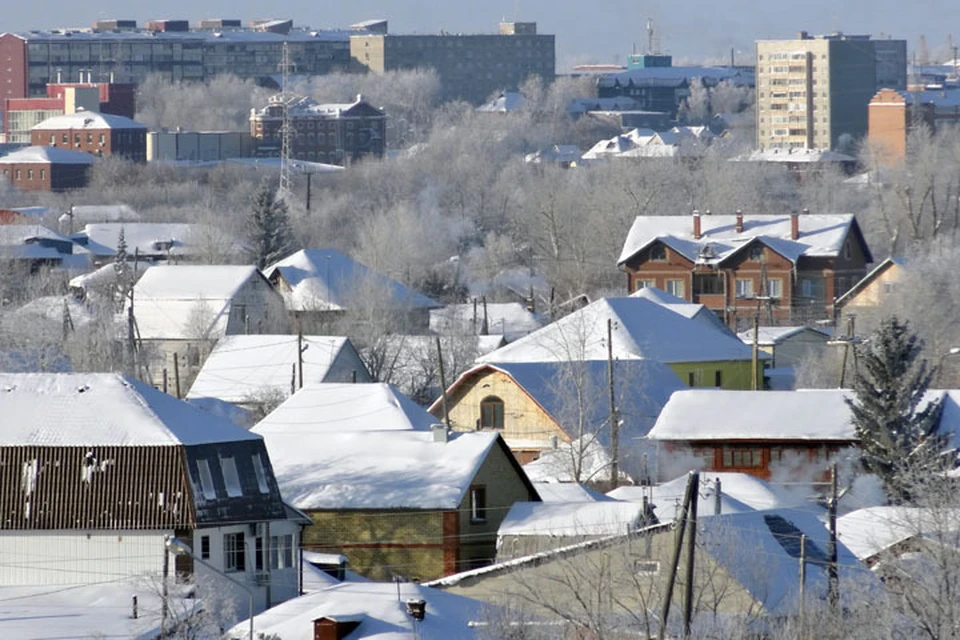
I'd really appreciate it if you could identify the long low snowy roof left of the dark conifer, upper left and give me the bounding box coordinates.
[72,222,242,259]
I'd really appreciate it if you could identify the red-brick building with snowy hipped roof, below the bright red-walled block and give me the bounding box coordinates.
[31,110,147,162]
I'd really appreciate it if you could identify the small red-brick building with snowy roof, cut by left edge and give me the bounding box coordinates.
[0,147,94,191]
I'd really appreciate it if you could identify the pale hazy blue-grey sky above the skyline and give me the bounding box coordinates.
[0,0,960,71]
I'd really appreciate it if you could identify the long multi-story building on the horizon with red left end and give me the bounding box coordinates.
[0,20,350,99]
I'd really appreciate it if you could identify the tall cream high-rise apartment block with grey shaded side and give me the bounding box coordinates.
[757,31,907,149]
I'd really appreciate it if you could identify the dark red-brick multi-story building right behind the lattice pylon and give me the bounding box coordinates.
[250,94,387,165]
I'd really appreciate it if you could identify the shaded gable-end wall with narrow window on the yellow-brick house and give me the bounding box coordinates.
[457,446,538,571]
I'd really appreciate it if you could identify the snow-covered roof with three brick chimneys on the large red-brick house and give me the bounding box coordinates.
[617,213,871,265]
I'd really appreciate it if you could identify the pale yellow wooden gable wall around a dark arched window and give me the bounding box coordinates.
[434,364,570,462]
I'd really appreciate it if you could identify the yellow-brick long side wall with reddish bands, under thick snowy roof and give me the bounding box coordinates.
[303,510,458,580]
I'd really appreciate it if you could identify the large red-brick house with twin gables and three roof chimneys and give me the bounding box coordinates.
[618,211,873,329]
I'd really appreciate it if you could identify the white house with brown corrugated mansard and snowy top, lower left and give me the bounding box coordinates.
[0,374,301,610]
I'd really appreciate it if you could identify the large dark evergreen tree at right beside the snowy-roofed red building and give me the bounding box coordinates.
[847,317,947,503]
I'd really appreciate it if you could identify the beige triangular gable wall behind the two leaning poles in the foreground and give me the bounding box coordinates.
[441,531,755,616]
